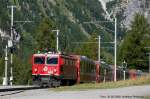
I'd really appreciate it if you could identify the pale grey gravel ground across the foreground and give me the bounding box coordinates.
[0,85,150,99]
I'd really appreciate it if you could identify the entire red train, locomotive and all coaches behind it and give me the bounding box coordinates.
[32,52,140,87]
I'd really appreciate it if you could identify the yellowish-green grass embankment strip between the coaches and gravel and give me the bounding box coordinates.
[53,75,150,91]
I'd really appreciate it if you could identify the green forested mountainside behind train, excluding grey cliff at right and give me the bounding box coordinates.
[0,0,119,54]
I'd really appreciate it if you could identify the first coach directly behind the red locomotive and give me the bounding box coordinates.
[76,56,99,83]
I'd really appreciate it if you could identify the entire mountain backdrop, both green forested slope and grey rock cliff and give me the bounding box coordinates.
[0,0,150,55]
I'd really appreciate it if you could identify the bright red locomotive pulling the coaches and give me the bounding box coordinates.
[32,53,77,87]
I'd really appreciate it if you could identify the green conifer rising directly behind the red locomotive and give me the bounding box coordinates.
[35,18,56,49]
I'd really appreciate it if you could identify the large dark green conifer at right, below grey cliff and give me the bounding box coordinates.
[119,14,150,69]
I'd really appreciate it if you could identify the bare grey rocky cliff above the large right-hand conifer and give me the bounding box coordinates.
[121,0,150,29]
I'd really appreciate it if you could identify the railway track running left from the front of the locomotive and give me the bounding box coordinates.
[0,86,46,92]
